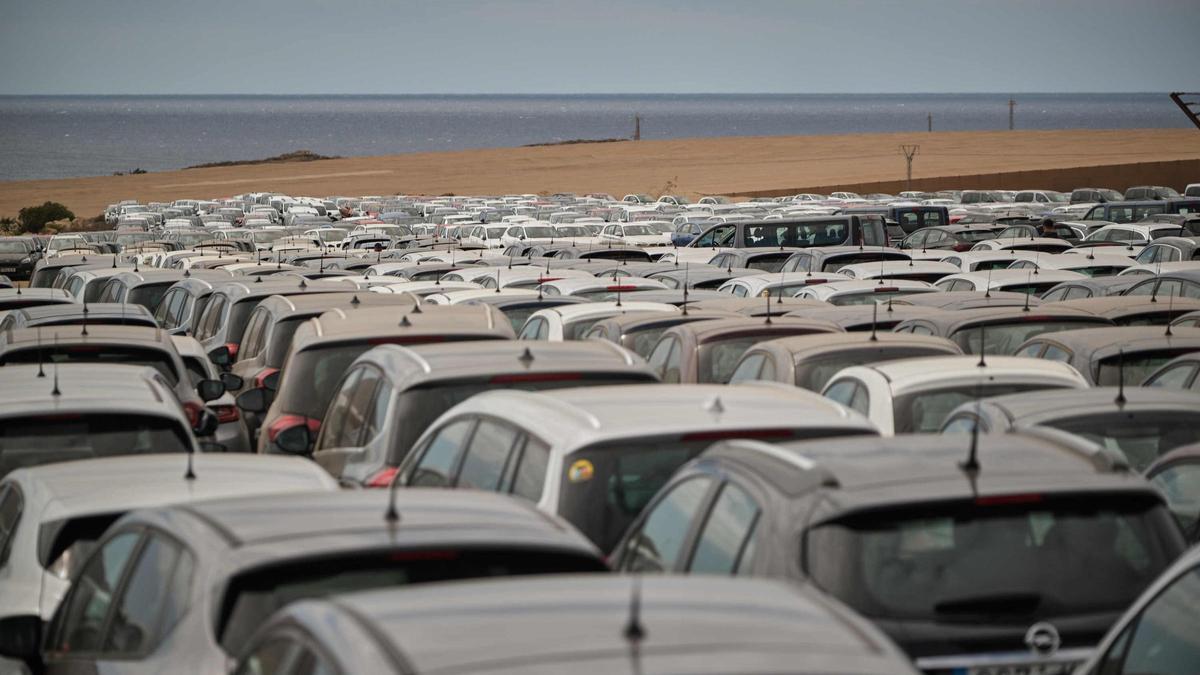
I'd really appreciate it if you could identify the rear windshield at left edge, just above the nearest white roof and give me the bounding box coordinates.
[0,413,191,476]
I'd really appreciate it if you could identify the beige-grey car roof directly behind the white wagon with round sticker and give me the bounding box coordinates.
[355,340,658,390]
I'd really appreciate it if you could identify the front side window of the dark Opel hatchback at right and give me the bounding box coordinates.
[623,478,713,572]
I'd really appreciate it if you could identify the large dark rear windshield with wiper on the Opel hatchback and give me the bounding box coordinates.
[805,494,1182,623]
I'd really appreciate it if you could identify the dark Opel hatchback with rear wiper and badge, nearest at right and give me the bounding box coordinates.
[612,430,1184,675]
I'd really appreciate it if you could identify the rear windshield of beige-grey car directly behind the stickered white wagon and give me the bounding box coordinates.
[388,372,658,466]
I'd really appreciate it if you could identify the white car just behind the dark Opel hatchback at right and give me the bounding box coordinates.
[822,356,1087,432]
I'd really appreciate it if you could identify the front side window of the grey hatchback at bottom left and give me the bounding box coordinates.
[48,532,140,652]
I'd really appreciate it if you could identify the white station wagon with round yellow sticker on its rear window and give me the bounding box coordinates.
[397,384,876,551]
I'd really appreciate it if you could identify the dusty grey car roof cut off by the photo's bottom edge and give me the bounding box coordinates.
[297,574,912,675]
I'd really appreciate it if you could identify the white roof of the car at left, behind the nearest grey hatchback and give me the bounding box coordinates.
[5,453,337,522]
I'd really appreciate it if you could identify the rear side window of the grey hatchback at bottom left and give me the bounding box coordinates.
[104,534,181,653]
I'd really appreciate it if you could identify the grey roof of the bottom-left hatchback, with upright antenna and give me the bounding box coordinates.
[166,488,595,551]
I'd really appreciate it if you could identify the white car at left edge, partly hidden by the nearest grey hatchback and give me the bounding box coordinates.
[0,453,337,620]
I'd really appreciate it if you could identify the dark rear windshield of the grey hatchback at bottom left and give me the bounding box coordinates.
[217,546,605,653]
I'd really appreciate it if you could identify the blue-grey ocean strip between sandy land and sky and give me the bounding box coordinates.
[0,94,1189,180]
